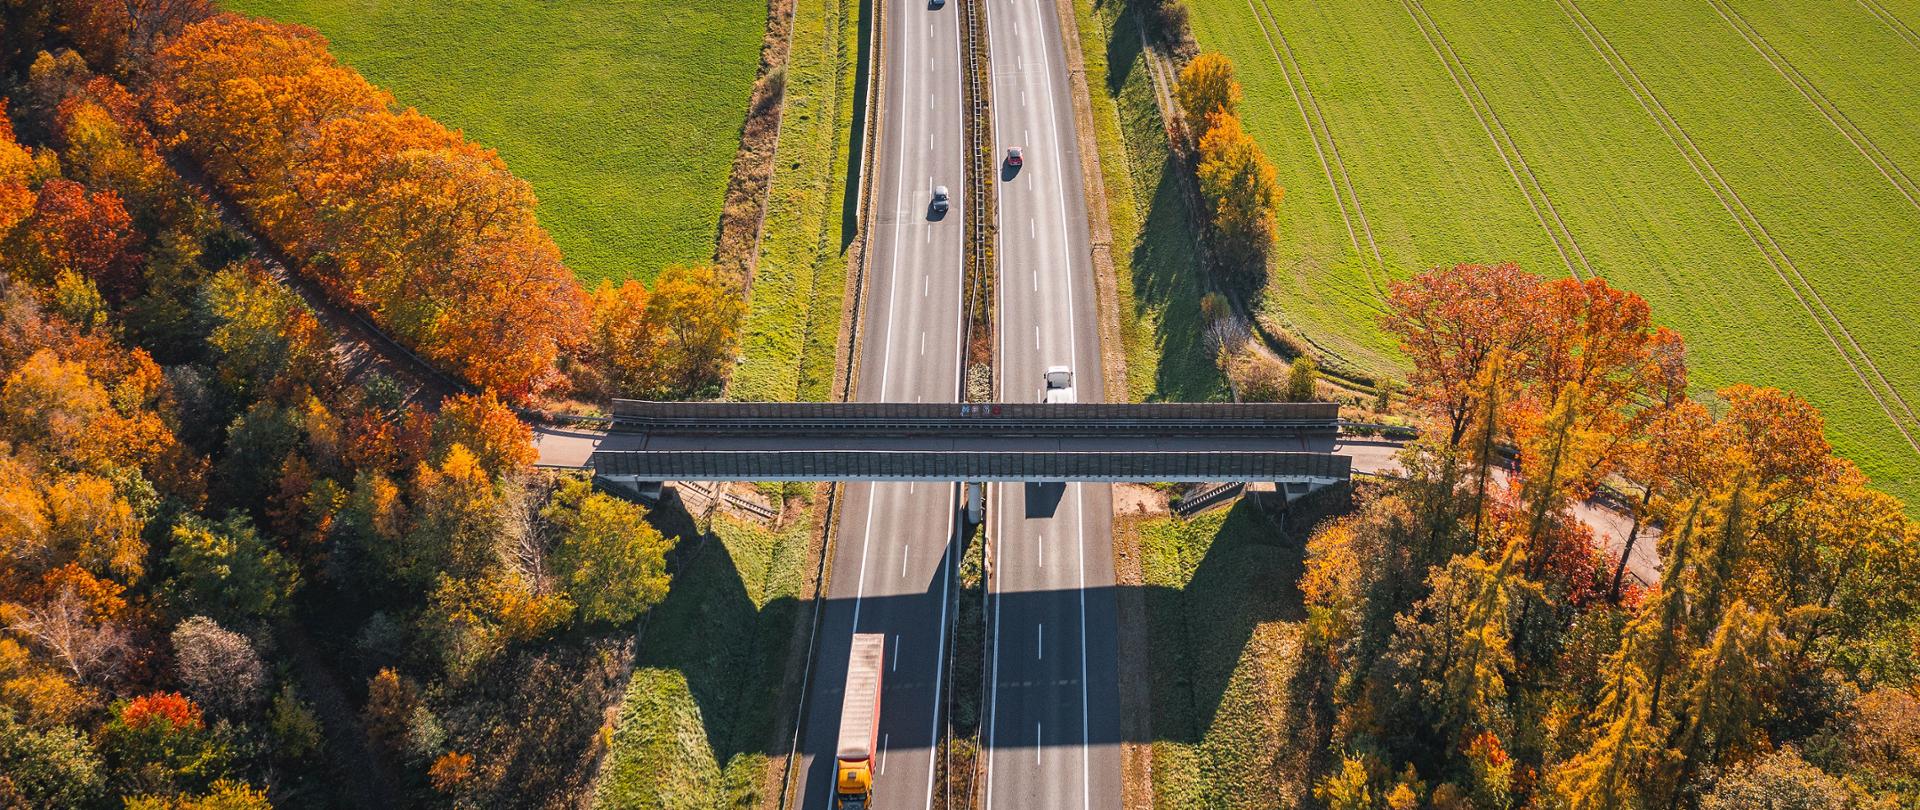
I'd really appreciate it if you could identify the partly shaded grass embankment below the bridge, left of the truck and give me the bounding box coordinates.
[593,516,814,810]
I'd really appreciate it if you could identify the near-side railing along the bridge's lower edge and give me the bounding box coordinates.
[588,449,1354,482]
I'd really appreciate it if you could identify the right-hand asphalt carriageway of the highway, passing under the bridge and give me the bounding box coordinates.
[985,0,1121,810]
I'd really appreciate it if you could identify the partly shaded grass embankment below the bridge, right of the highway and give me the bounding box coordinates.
[1117,499,1313,808]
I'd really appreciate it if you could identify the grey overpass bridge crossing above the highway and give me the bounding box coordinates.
[536,399,1352,495]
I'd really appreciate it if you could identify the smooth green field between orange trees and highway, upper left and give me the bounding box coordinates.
[225,0,766,282]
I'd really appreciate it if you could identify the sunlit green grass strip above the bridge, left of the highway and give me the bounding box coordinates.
[728,0,860,401]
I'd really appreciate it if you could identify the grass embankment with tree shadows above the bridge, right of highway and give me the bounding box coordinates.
[1073,0,1227,401]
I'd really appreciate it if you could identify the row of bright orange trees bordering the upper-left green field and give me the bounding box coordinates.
[154,15,588,399]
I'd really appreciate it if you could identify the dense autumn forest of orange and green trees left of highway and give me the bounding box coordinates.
[0,0,725,808]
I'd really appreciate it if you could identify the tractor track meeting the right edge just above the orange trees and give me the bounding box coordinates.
[1555,0,1920,455]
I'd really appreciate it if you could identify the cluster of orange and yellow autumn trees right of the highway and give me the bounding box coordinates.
[1294,265,1920,810]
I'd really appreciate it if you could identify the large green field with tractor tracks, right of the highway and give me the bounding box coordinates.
[1190,0,1920,503]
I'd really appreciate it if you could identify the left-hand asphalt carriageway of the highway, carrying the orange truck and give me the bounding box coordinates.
[799,0,968,808]
